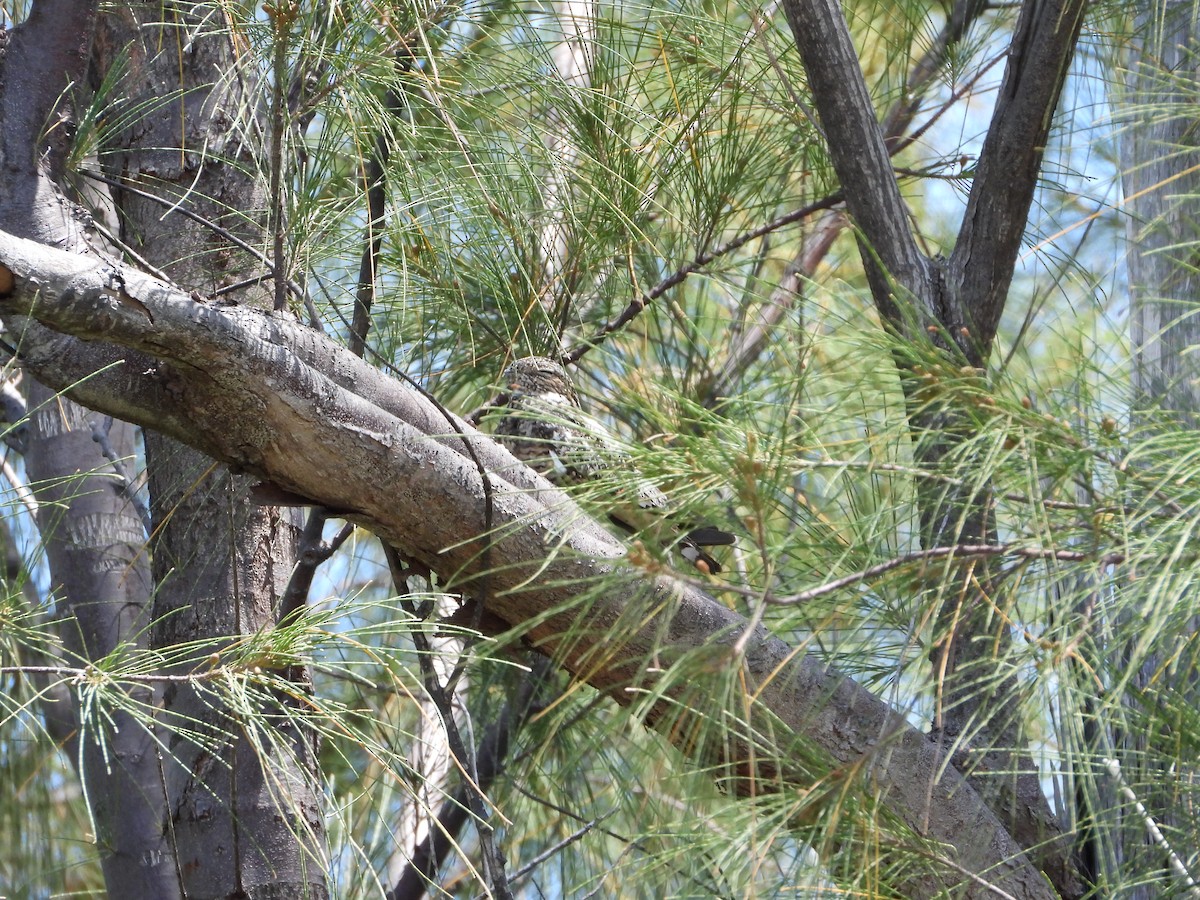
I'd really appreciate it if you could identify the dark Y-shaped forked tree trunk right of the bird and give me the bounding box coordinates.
[784,0,1086,895]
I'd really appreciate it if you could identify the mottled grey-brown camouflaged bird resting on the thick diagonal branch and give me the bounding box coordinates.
[496,356,734,575]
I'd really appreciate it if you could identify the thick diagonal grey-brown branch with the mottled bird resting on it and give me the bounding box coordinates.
[0,235,1050,898]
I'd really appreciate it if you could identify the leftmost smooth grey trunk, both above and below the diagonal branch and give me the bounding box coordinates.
[0,0,178,899]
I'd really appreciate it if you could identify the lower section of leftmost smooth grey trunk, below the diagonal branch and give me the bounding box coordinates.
[25,391,179,898]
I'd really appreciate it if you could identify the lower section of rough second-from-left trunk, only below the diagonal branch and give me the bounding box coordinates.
[146,448,326,898]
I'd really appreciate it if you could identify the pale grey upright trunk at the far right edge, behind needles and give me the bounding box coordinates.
[1096,0,1200,900]
